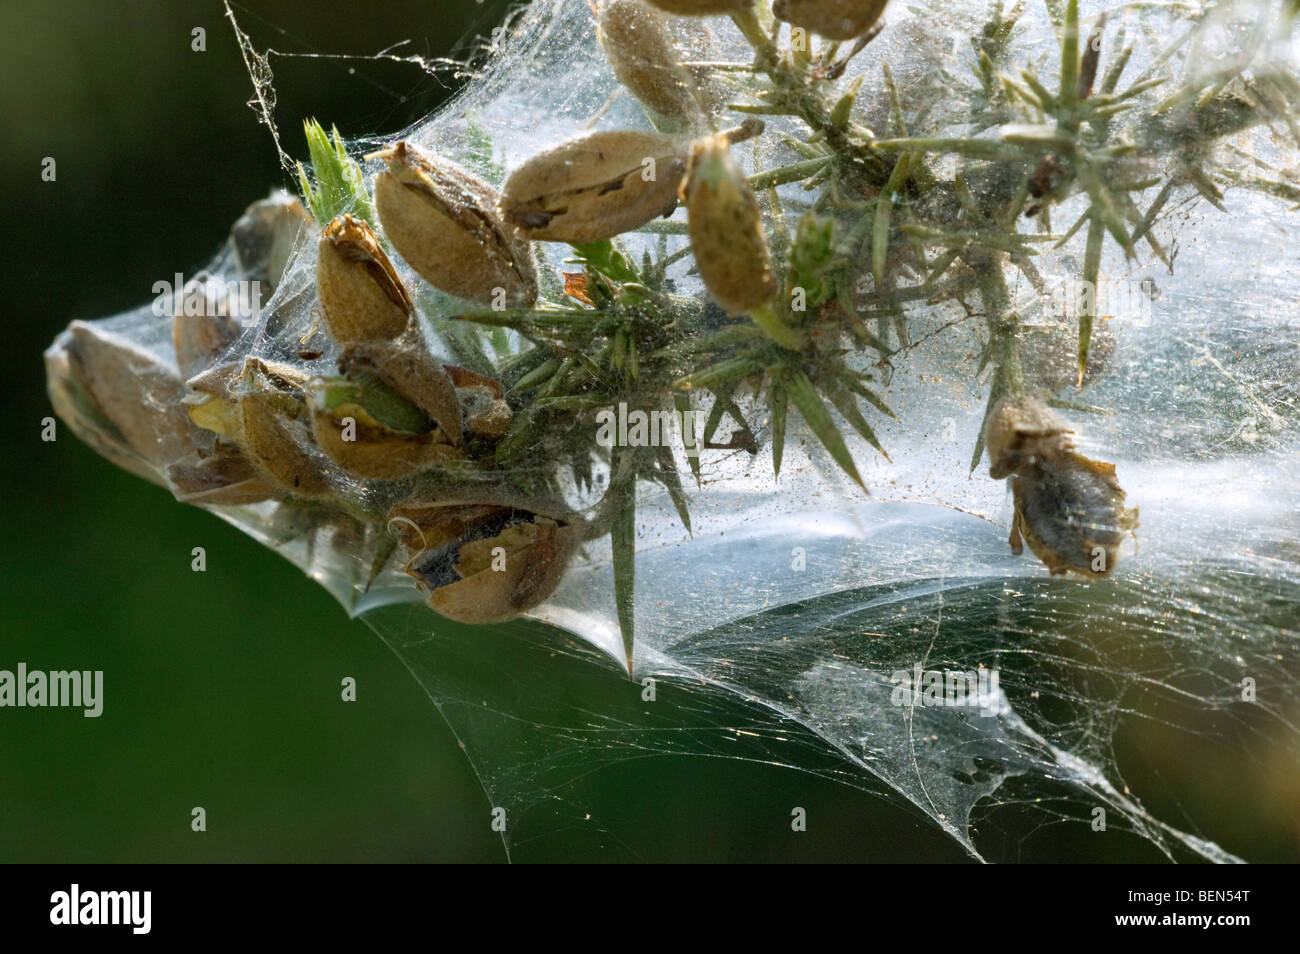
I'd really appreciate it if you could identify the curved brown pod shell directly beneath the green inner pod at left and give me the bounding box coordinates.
[312,404,460,481]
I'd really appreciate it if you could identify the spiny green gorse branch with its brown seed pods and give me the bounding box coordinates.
[51,0,1300,668]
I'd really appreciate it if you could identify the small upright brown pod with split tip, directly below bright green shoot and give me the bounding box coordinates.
[316,214,415,344]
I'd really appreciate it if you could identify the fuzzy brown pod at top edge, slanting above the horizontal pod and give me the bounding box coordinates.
[595,0,712,130]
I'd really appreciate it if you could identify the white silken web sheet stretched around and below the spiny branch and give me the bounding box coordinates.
[45,0,1300,860]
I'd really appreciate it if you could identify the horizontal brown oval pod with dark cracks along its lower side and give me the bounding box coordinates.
[502,130,686,243]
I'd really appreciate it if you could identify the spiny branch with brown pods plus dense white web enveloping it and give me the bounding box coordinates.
[38,0,1300,868]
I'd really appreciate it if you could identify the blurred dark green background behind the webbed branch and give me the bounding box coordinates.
[0,0,1296,862]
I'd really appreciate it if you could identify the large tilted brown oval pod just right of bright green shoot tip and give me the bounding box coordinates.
[368,142,537,308]
